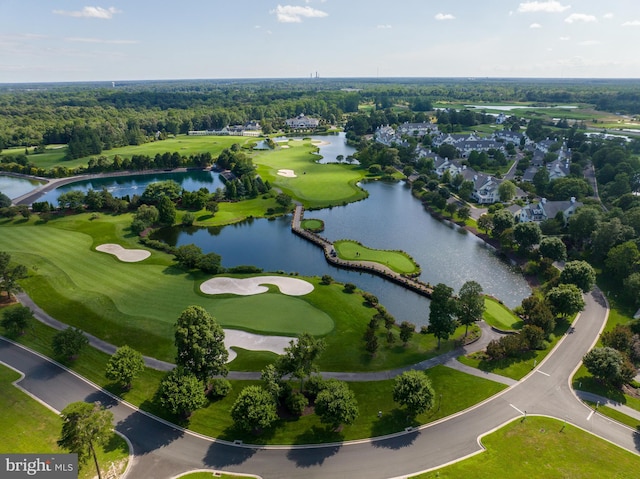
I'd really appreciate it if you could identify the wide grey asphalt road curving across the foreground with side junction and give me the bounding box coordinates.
[0,291,640,479]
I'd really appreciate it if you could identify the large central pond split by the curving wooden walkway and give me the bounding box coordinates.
[154,182,531,326]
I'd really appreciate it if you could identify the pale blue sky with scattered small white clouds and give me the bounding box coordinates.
[0,0,640,83]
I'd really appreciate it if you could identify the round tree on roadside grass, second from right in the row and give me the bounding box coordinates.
[315,379,359,430]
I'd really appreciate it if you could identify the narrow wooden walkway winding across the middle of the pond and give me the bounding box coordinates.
[291,205,432,298]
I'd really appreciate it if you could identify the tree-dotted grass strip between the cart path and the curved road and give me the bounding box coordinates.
[0,316,506,444]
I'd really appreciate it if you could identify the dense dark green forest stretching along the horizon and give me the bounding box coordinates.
[0,79,640,152]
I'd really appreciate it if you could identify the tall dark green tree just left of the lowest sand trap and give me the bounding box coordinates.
[175,306,229,383]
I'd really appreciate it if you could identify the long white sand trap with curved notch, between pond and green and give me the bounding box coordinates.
[200,276,313,296]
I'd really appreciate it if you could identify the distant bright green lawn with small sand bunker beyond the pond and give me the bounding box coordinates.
[253,140,367,209]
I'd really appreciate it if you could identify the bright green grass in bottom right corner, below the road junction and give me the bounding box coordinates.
[415,416,640,479]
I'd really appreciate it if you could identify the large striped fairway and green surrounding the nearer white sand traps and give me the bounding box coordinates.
[0,214,462,371]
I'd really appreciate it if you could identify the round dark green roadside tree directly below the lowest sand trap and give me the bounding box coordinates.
[231,386,278,432]
